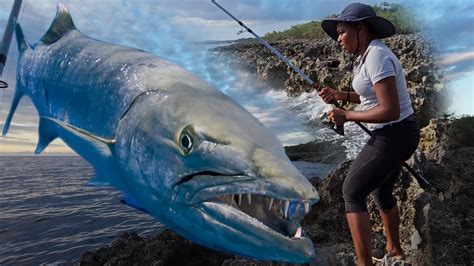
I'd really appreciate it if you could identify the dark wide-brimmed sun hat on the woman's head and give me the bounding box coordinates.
[321,3,396,41]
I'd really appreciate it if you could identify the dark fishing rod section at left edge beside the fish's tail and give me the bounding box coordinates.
[0,0,22,89]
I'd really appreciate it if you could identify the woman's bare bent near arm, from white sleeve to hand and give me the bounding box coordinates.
[328,76,400,125]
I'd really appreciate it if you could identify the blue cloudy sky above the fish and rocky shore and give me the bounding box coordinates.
[0,0,474,155]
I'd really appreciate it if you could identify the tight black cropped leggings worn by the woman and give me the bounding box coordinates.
[342,116,420,213]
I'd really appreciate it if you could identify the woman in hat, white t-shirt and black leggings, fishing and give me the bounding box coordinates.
[319,3,419,265]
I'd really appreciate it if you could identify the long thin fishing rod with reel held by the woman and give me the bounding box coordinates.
[211,0,431,188]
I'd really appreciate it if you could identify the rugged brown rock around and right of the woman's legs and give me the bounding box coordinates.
[304,117,474,265]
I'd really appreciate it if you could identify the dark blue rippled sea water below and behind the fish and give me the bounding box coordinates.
[0,156,334,265]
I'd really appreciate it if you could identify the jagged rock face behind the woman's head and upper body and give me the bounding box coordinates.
[214,34,448,126]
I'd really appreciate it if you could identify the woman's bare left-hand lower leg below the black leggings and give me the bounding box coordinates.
[346,212,372,265]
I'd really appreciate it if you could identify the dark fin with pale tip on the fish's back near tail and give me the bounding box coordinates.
[41,3,76,44]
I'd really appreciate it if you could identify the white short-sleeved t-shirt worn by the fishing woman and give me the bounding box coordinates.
[352,39,413,130]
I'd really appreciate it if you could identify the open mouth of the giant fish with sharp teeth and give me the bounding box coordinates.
[175,172,315,262]
